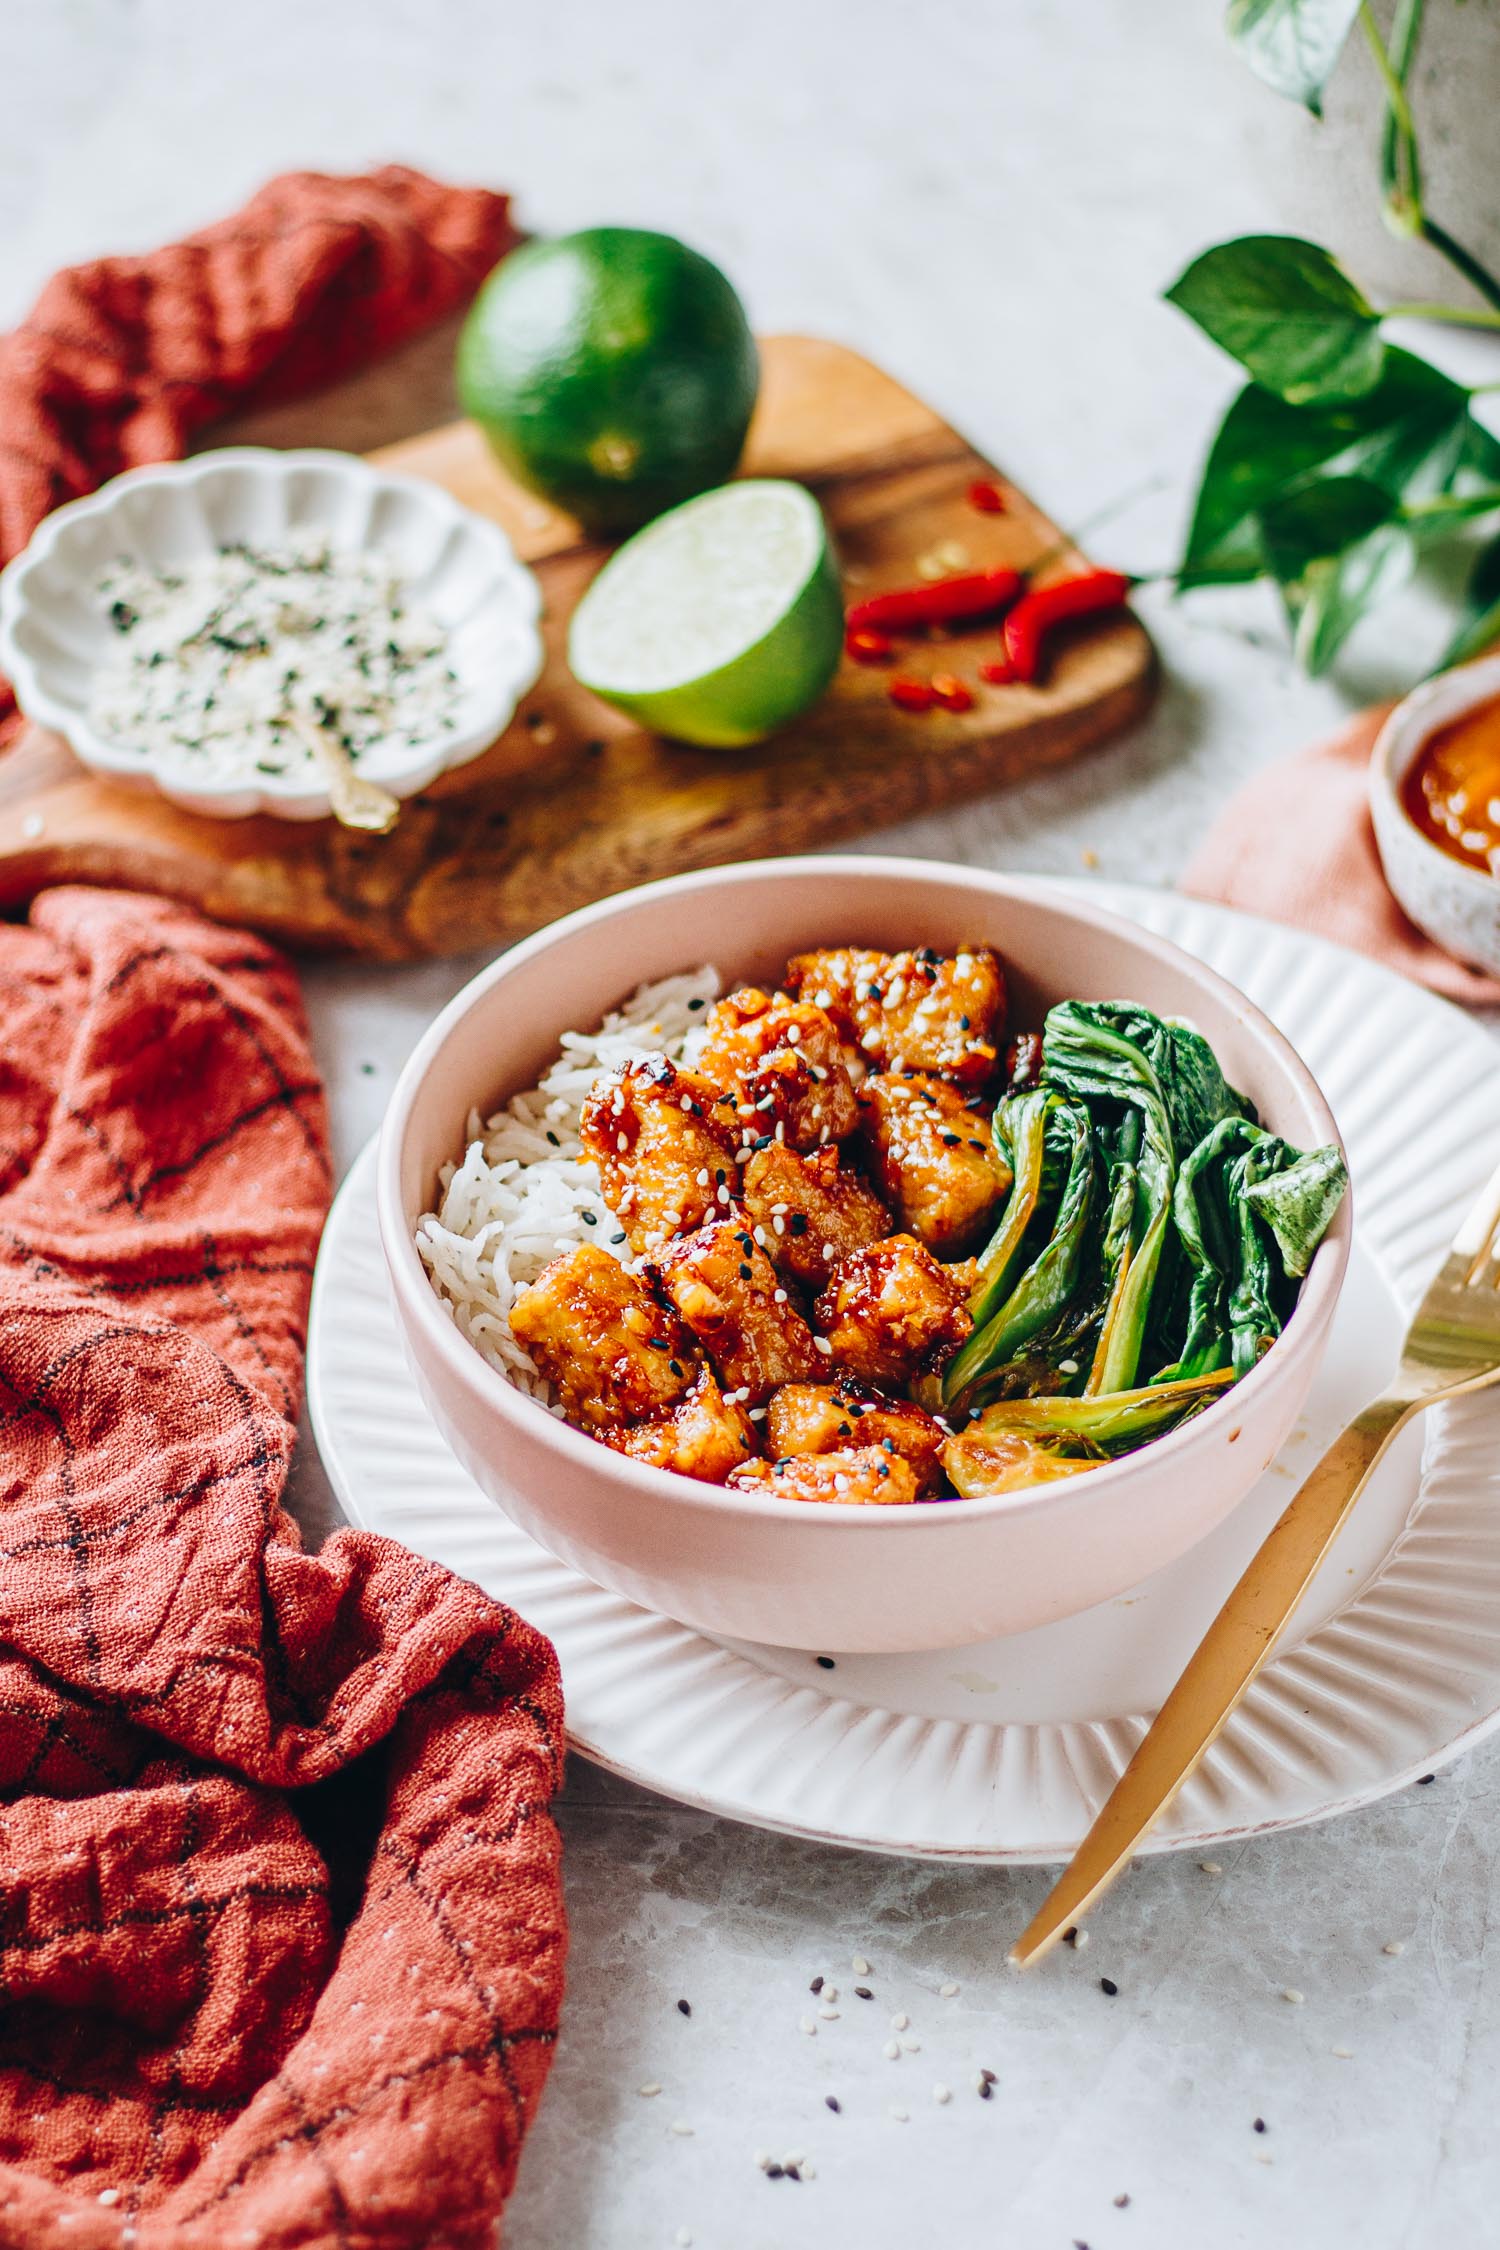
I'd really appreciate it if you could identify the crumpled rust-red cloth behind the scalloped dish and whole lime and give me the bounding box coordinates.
[0,164,519,745]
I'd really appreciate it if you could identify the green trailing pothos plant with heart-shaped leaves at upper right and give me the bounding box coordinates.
[1167,0,1500,673]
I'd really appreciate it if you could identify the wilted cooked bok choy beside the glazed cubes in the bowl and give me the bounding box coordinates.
[942,1001,1347,1492]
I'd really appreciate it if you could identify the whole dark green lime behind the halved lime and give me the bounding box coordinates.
[457,227,760,536]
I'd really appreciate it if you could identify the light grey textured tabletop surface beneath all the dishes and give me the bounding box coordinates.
[11,0,1500,2250]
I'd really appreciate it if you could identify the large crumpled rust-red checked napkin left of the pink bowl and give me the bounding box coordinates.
[0,889,564,2250]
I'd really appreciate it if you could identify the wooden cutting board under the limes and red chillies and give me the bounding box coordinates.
[0,335,1154,961]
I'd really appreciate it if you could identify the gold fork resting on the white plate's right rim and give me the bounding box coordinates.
[1010,1172,1500,1969]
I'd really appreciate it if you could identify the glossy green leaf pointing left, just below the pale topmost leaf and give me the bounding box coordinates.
[1167,234,1385,405]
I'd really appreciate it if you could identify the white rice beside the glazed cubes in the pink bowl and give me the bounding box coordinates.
[416,968,720,1415]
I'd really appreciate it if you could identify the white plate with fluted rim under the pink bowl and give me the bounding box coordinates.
[308,884,1500,1865]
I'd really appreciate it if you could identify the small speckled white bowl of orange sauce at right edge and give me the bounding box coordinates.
[1370,655,1500,977]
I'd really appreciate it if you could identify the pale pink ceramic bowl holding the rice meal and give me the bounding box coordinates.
[378,857,1349,1652]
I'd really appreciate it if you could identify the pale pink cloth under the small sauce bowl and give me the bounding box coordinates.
[1183,711,1500,1006]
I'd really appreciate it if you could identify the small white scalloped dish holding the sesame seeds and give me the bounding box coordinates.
[0,446,542,821]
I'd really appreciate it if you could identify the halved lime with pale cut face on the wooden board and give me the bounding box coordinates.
[567,477,843,749]
